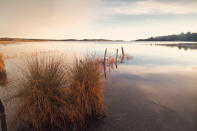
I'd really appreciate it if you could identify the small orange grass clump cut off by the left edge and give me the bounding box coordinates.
[0,53,7,84]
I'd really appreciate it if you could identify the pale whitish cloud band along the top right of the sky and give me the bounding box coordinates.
[102,0,197,15]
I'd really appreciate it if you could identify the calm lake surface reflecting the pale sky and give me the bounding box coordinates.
[0,42,197,131]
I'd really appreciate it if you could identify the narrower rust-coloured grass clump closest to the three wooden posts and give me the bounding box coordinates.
[69,56,105,120]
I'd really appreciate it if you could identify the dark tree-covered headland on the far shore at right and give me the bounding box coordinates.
[136,32,197,41]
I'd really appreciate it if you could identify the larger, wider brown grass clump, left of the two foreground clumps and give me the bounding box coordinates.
[15,56,81,131]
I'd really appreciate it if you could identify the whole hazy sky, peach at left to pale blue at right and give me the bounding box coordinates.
[0,0,197,40]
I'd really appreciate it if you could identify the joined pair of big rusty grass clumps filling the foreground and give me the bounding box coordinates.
[14,55,104,131]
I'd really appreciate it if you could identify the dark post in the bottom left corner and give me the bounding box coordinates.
[0,99,7,131]
